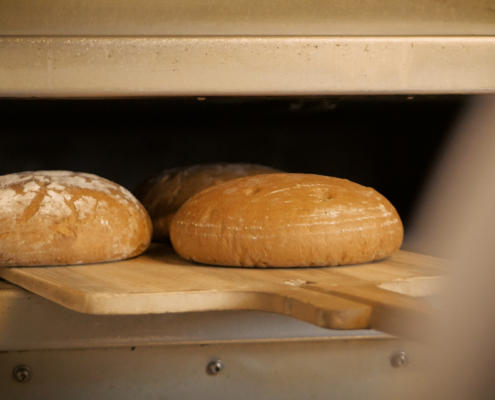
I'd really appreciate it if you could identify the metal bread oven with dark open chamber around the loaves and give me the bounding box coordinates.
[0,0,495,399]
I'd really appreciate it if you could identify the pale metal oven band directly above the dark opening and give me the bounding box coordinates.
[0,36,495,97]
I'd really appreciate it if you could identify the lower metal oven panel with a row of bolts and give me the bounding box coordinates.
[0,339,426,400]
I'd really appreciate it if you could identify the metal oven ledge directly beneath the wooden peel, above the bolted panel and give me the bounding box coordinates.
[0,281,388,352]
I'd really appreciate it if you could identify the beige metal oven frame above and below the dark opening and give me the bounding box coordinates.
[0,0,495,399]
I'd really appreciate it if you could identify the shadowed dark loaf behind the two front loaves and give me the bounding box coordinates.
[134,163,280,242]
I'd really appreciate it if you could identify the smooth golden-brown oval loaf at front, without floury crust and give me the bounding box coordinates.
[170,174,403,267]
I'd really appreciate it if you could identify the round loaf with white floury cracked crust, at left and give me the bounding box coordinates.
[0,171,151,266]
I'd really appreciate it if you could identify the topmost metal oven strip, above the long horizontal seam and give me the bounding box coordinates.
[0,0,495,35]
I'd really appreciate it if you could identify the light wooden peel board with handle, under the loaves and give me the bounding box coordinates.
[0,244,447,336]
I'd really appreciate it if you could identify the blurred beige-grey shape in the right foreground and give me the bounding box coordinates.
[411,96,495,400]
